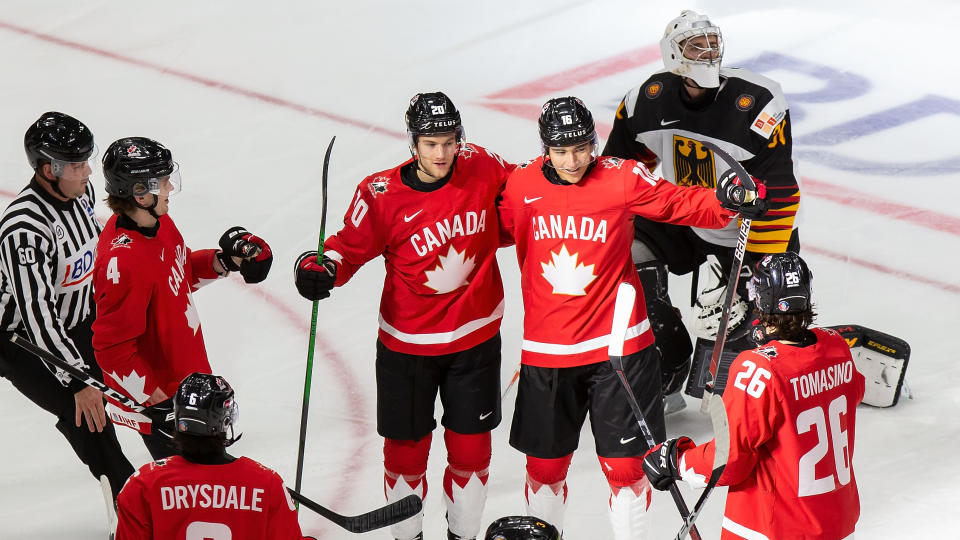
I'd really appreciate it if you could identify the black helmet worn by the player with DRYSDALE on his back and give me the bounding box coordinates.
[173,373,239,446]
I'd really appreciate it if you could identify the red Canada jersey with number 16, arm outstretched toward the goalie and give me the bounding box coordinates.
[500,157,735,367]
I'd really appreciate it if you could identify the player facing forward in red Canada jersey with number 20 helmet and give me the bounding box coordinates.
[295,92,513,540]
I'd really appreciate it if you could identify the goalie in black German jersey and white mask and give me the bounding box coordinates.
[603,10,800,411]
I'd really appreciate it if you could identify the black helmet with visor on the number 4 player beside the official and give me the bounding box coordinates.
[103,137,180,198]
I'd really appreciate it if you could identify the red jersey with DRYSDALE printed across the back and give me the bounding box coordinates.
[116,456,303,540]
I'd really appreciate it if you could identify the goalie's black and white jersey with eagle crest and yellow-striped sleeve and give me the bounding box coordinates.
[603,68,800,253]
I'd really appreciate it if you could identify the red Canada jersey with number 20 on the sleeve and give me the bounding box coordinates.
[324,143,514,356]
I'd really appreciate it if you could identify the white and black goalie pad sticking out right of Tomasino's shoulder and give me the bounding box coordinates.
[828,324,910,407]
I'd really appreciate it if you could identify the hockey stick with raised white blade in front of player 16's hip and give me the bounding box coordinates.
[607,283,700,540]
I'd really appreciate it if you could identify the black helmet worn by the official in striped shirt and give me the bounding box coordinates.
[23,111,97,176]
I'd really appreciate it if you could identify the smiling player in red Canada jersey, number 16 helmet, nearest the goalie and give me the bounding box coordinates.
[500,97,764,540]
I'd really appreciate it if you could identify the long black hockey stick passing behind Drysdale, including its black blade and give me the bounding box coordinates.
[10,334,423,533]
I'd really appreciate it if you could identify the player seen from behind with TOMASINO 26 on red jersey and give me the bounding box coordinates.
[643,251,864,540]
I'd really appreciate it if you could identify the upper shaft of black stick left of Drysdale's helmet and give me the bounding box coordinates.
[10,334,173,438]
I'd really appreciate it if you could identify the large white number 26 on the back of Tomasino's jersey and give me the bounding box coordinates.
[797,396,850,497]
